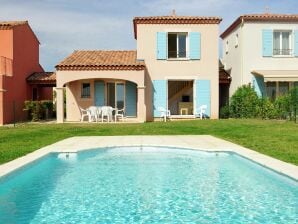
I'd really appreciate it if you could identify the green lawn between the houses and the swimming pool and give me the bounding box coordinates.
[0,120,298,165]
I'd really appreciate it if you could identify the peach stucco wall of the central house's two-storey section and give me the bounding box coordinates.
[137,24,219,119]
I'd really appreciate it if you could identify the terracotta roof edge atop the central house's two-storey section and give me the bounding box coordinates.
[133,15,222,39]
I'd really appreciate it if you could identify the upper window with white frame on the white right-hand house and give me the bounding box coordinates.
[273,31,292,55]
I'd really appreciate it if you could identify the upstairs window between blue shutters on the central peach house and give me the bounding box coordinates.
[168,33,187,58]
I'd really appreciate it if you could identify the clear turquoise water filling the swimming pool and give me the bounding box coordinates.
[0,147,298,224]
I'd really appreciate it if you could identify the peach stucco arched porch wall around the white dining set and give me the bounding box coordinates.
[56,70,146,122]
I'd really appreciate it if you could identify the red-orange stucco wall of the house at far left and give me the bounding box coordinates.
[0,24,43,124]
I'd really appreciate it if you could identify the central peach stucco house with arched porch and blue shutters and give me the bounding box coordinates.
[56,14,221,122]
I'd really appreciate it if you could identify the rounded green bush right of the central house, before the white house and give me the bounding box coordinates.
[230,85,259,118]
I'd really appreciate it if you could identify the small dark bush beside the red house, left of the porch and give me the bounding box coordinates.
[23,100,53,121]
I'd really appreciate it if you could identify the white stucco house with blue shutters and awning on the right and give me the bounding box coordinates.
[220,13,298,99]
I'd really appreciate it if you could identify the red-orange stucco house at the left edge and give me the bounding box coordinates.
[0,21,55,125]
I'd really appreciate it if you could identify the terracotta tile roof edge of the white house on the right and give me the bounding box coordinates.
[220,13,298,39]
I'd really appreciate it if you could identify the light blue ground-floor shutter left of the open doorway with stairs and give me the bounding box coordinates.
[153,80,167,117]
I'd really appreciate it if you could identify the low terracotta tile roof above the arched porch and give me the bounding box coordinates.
[56,50,145,70]
